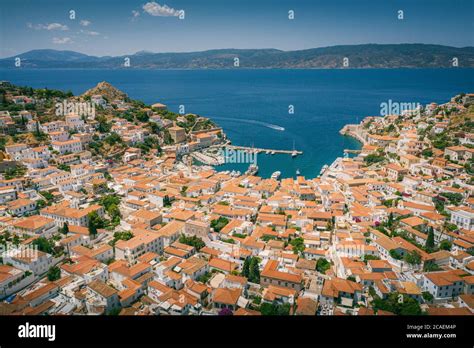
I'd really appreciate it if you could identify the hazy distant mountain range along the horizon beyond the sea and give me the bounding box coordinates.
[0,44,474,69]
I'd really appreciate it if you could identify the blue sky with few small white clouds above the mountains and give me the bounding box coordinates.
[0,0,474,58]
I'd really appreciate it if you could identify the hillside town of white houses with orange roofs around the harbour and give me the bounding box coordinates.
[0,81,474,315]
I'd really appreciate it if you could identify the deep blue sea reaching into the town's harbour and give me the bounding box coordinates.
[0,69,474,178]
